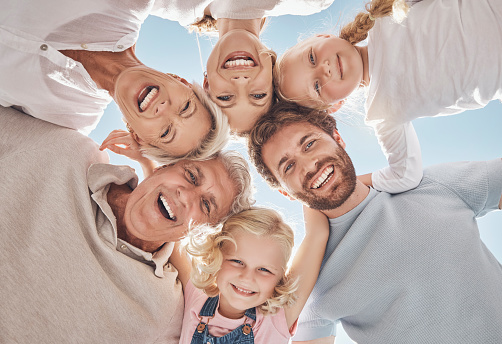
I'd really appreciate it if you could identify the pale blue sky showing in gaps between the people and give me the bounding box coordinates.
[90,0,502,344]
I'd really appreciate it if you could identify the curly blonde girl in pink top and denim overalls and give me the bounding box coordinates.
[171,208,329,344]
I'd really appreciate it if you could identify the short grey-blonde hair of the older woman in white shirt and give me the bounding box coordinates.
[140,82,230,165]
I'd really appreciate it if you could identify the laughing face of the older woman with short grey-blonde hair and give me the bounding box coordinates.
[114,67,211,157]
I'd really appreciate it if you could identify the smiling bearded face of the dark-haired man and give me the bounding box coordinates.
[262,122,356,210]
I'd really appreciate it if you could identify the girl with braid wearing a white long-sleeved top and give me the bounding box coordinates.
[274,0,502,193]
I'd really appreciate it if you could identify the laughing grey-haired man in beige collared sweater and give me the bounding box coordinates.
[0,107,252,343]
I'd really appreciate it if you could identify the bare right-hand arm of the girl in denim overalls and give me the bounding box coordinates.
[285,206,329,328]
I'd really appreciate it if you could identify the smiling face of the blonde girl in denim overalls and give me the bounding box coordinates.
[216,231,287,319]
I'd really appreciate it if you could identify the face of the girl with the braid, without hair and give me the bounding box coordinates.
[280,35,363,107]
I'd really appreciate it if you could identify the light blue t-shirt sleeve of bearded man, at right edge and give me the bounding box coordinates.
[424,158,502,217]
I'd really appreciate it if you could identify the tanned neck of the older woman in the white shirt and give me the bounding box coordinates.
[60,46,143,95]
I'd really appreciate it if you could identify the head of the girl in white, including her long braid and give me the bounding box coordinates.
[273,0,407,109]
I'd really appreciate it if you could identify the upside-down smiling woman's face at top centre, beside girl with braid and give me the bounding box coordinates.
[204,30,273,132]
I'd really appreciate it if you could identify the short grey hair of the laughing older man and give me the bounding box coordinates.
[216,150,255,216]
